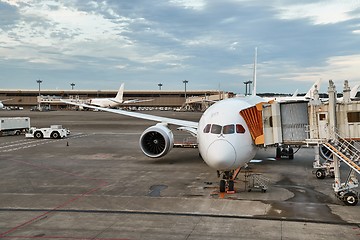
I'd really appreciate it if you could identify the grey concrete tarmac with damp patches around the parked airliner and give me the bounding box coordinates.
[0,110,360,240]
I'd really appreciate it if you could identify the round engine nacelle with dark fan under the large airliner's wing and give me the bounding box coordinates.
[139,123,174,158]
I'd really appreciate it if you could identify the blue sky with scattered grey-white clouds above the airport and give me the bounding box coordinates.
[0,0,360,93]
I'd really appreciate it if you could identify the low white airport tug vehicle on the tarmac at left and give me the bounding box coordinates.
[25,125,70,139]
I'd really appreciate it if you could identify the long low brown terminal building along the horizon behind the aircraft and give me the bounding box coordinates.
[0,89,233,109]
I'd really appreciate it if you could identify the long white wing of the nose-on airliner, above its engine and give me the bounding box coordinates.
[61,100,198,131]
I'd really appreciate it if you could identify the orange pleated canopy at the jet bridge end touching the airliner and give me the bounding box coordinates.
[240,103,264,145]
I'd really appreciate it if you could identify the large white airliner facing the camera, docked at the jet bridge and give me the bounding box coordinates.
[64,91,264,192]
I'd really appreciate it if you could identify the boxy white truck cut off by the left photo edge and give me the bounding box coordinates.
[0,117,30,136]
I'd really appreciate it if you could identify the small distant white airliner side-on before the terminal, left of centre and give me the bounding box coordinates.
[86,83,152,108]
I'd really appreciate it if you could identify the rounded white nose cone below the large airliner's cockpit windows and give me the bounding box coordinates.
[206,140,236,170]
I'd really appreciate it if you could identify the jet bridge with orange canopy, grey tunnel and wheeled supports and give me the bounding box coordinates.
[240,80,360,205]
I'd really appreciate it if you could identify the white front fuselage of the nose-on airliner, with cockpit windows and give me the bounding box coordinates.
[197,98,256,171]
